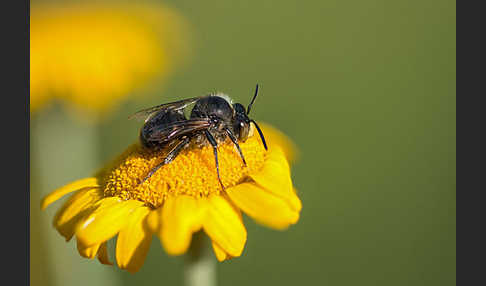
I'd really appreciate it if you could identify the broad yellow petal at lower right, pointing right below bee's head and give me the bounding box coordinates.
[226,183,299,229]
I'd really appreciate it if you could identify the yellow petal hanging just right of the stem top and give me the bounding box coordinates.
[200,195,246,257]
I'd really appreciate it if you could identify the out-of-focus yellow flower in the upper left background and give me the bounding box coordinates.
[30,2,190,113]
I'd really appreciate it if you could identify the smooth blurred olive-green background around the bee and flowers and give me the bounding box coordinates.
[30,0,456,286]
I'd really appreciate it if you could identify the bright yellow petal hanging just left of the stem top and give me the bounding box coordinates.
[160,195,203,255]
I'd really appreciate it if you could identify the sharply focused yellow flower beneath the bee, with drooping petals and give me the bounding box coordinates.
[41,124,302,272]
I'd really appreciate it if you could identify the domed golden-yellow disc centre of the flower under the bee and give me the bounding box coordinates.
[100,136,266,208]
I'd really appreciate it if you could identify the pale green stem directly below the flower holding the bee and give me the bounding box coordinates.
[184,231,216,286]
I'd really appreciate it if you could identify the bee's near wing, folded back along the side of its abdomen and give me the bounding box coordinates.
[146,118,210,143]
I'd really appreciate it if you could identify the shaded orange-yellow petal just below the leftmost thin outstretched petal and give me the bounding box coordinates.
[54,188,103,241]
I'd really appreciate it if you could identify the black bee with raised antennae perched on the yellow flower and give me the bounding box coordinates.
[129,84,268,190]
